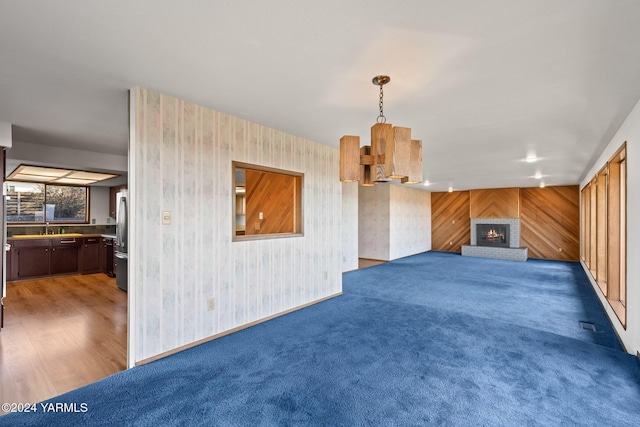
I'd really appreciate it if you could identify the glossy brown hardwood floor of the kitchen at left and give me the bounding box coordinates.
[0,273,127,415]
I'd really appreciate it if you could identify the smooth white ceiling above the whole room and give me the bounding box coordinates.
[0,0,640,191]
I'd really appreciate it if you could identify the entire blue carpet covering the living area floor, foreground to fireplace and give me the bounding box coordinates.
[0,252,640,426]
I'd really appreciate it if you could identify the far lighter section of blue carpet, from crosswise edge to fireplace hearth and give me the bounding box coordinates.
[342,252,622,350]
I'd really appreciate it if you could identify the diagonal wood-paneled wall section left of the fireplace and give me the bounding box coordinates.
[431,191,471,252]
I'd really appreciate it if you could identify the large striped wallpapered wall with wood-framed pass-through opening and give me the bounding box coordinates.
[129,88,342,361]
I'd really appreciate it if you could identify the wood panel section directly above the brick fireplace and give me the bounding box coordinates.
[470,188,520,218]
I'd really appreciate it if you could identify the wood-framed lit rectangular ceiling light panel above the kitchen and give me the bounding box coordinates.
[7,165,120,186]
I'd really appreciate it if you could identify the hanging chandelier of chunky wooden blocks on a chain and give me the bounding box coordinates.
[340,76,422,186]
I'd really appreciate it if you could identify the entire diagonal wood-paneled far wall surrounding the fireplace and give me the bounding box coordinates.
[431,185,580,261]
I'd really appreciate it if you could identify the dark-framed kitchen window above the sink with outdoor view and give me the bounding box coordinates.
[6,181,89,223]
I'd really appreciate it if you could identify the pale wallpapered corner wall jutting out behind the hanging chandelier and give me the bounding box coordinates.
[358,184,431,261]
